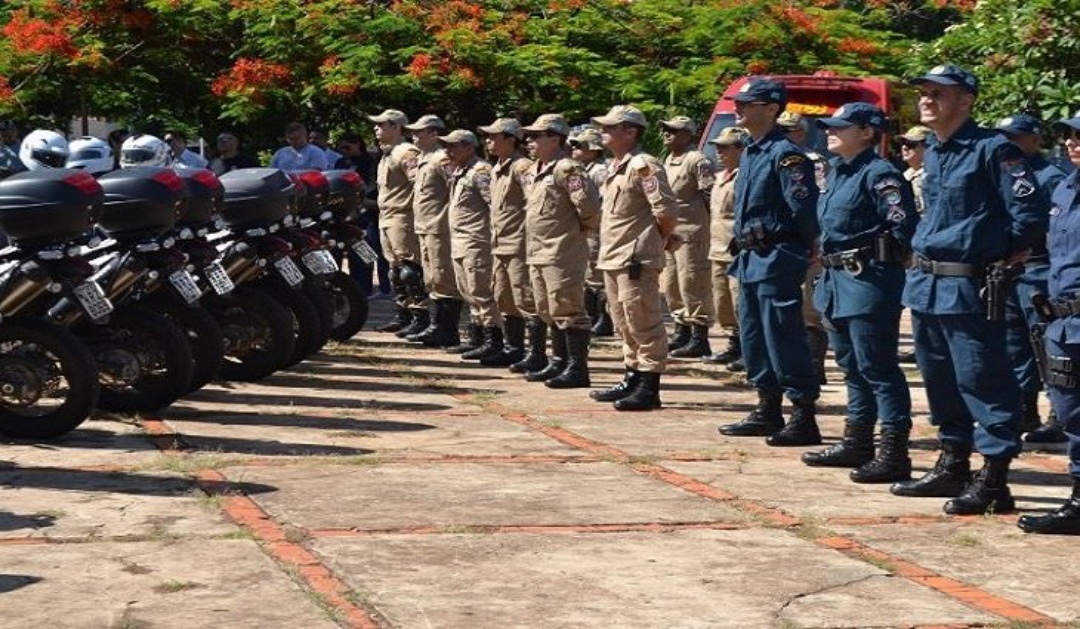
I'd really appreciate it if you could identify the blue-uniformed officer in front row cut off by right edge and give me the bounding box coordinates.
[1017,111,1080,535]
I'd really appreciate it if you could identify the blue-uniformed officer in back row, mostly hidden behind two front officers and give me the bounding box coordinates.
[997,113,1067,444]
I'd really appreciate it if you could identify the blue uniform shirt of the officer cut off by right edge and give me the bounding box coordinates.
[1047,171,1080,344]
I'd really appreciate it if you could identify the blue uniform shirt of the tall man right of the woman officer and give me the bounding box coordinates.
[904,120,1047,315]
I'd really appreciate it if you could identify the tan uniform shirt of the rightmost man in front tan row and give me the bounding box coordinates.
[596,151,678,271]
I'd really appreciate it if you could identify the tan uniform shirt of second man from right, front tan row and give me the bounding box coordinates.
[525,155,600,269]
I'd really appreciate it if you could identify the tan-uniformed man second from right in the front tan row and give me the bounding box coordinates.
[525,113,600,389]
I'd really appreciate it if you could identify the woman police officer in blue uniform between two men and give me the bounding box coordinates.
[802,103,919,483]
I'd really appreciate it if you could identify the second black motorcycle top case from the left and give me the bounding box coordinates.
[97,166,187,239]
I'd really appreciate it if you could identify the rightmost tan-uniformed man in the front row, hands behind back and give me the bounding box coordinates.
[590,105,678,411]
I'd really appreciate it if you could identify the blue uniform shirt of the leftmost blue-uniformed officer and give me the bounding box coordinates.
[728,126,818,283]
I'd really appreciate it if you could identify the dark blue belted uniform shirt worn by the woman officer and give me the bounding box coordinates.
[813,148,919,319]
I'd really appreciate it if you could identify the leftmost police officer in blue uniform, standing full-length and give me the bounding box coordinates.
[719,77,821,446]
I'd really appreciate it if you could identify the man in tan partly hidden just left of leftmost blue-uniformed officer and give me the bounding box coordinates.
[704,126,750,364]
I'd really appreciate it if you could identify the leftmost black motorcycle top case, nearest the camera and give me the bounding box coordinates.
[0,169,104,247]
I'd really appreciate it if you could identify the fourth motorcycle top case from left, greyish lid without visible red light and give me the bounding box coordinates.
[219,169,297,228]
